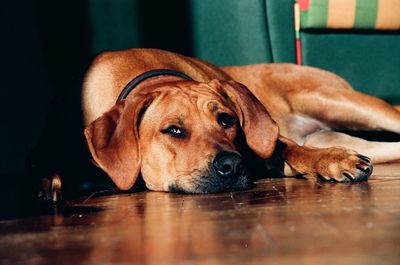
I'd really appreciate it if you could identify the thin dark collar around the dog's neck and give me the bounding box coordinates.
[117,69,193,103]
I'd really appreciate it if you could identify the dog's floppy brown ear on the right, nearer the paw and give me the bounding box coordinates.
[209,80,279,158]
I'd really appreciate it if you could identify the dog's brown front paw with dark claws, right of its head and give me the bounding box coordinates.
[315,148,373,182]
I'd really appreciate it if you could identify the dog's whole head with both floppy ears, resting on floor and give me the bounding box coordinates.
[85,80,278,193]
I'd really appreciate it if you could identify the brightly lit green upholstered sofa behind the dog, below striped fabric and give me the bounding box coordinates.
[192,0,400,104]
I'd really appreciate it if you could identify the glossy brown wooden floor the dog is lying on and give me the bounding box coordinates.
[0,164,400,265]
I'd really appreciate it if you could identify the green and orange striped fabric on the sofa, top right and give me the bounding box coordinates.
[298,0,400,30]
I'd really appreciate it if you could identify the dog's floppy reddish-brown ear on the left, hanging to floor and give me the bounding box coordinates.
[85,94,154,190]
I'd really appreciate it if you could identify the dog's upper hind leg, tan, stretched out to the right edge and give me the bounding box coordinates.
[290,86,400,134]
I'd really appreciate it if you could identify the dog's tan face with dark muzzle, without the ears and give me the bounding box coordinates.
[139,81,247,192]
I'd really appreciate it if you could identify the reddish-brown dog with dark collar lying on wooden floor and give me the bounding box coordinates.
[41,49,400,198]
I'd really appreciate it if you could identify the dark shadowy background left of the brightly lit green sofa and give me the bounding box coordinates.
[0,0,192,176]
